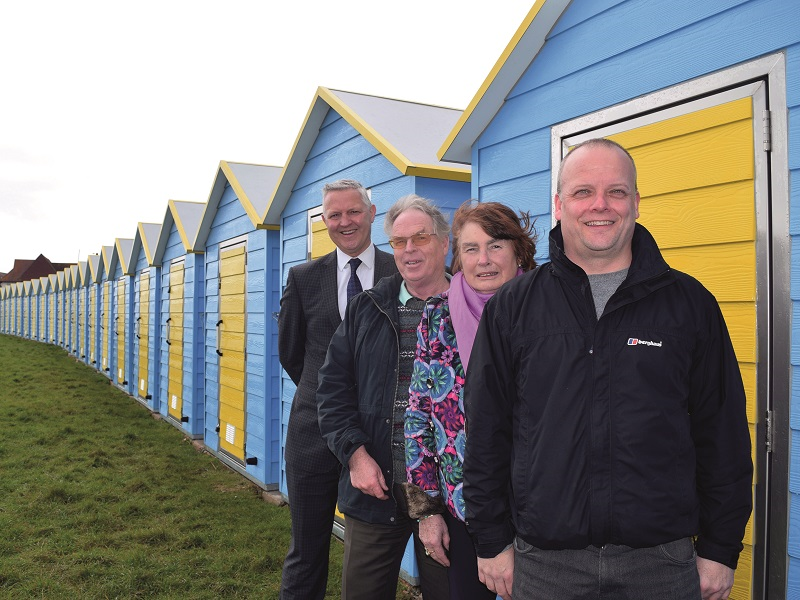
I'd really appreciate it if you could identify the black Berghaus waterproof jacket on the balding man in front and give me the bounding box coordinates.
[464,224,752,568]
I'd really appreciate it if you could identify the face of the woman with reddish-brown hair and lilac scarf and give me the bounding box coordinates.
[458,221,517,294]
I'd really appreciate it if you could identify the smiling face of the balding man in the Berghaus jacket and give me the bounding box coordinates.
[555,145,639,274]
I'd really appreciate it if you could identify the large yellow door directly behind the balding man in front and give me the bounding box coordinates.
[606,96,758,599]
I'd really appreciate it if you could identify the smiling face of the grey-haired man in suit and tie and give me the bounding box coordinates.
[322,189,375,256]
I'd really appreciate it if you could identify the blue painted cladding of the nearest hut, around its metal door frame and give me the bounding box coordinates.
[472,0,800,597]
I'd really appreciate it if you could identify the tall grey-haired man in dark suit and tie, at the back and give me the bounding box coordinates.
[278,179,397,600]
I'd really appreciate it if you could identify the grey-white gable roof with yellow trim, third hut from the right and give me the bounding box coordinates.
[193,160,283,250]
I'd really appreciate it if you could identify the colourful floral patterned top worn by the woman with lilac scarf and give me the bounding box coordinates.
[405,292,466,521]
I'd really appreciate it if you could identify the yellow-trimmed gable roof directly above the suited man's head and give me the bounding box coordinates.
[262,87,471,225]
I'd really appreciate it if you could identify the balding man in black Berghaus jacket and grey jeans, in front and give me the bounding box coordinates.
[464,139,752,600]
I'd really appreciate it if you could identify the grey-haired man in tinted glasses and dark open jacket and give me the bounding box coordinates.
[317,195,450,600]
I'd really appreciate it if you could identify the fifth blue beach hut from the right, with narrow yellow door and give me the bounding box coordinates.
[130,223,161,411]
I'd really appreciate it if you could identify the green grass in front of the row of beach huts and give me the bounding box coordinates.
[0,335,422,600]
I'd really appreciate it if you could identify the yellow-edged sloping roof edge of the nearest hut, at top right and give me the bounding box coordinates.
[437,0,570,163]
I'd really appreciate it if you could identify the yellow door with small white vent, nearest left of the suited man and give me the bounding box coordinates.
[217,245,247,462]
